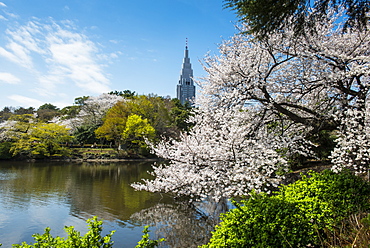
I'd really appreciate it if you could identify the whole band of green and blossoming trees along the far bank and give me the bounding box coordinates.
[0,90,191,159]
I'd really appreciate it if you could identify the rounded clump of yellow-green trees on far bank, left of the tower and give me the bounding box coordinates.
[95,95,190,154]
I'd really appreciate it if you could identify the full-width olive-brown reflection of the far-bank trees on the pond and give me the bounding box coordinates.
[0,161,174,221]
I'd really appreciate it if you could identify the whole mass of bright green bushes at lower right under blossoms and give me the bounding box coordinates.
[202,171,370,248]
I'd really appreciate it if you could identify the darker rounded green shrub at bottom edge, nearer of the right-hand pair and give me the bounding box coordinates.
[202,194,311,248]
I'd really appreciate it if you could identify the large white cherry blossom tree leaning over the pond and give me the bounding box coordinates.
[133,9,370,201]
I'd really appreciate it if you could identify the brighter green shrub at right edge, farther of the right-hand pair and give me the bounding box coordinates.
[275,170,370,228]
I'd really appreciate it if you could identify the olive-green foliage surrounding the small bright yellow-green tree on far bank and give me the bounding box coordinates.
[95,94,191,153]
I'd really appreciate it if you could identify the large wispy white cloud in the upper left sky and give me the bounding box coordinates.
[0,19,112,96]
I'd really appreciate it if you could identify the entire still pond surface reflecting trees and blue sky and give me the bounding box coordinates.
[0,161,212,248]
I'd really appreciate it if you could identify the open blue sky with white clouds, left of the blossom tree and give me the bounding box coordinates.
[0,0,236,110]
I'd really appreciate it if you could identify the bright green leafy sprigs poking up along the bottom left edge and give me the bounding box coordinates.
[0,217,164,248]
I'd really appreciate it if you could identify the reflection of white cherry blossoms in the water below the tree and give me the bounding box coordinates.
[130,203,224,247]
